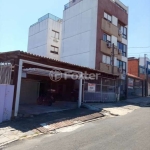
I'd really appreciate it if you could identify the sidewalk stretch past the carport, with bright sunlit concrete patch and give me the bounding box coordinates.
[84,97,150,116]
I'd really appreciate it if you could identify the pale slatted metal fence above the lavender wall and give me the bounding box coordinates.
[0,62,12,84]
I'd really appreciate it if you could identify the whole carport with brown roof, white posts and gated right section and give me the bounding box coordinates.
[0,51,118,116]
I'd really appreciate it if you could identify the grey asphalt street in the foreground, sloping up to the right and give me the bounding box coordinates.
[3,107,150,150]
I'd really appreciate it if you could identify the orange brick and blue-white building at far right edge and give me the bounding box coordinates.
[128,57,150,95]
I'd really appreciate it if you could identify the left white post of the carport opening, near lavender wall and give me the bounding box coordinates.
[14,60,23,117]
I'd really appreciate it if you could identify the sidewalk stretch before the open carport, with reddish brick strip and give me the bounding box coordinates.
[0,108,103,147]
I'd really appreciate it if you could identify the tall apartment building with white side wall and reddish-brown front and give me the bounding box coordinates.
[60,0,128,97]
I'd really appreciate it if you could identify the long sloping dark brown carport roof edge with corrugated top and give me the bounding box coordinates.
[0,50,119,77]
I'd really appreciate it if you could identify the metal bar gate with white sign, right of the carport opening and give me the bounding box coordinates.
[83,78,117,103]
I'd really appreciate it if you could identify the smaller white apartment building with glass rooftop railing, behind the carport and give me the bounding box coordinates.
[27,14,62,60]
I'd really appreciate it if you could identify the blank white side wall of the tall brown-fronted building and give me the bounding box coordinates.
[61,0,98,68]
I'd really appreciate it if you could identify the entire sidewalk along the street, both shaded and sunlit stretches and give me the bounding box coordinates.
[0,97,150,147]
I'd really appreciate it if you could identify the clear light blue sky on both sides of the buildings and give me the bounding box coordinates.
[0,0,150,58]
